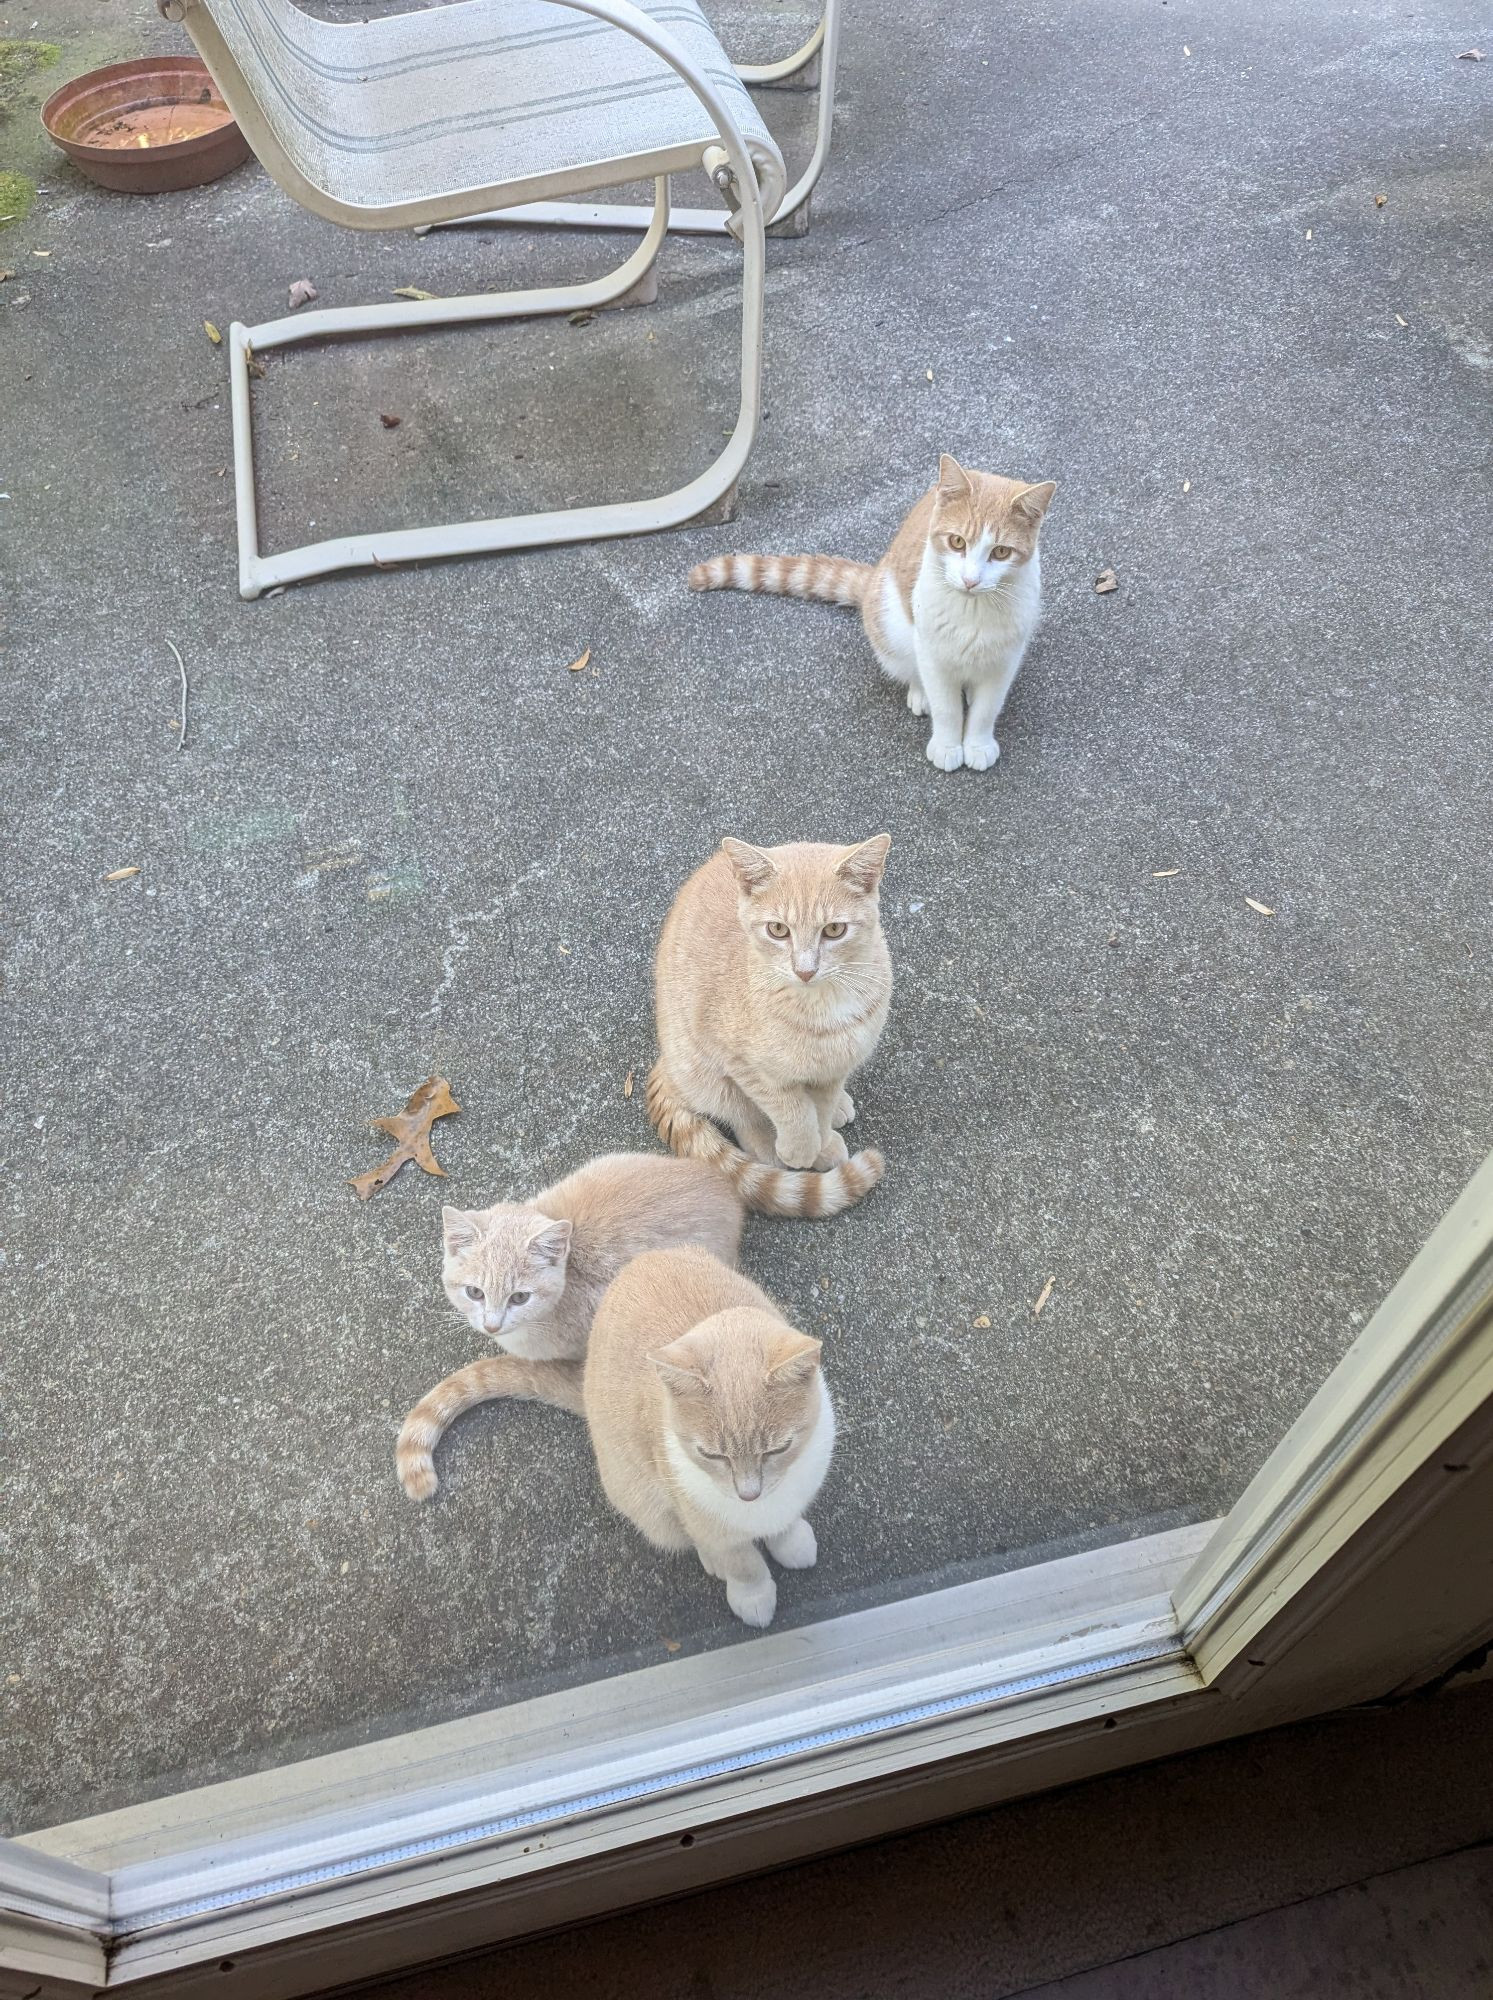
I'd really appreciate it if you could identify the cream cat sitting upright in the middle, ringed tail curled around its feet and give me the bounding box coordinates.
[648,834,893,1216]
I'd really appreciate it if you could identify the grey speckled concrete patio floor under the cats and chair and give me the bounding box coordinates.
[0,0,1493,1832]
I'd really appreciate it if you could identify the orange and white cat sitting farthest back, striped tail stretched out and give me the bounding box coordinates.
[690,452,1057,770]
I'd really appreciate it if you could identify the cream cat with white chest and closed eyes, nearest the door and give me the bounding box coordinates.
[406,1250,835,1626]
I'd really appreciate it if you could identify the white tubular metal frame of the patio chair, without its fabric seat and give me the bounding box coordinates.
[160,0,783,598]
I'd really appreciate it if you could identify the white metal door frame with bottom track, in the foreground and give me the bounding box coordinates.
[11,1162,1493,2000]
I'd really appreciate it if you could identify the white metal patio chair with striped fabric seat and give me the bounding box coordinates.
[158,0,785,598]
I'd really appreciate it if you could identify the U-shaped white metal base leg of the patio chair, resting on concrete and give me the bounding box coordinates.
[228,178,767,598]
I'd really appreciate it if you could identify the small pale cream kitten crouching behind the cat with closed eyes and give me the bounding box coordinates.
[394,1152,740,1500]
